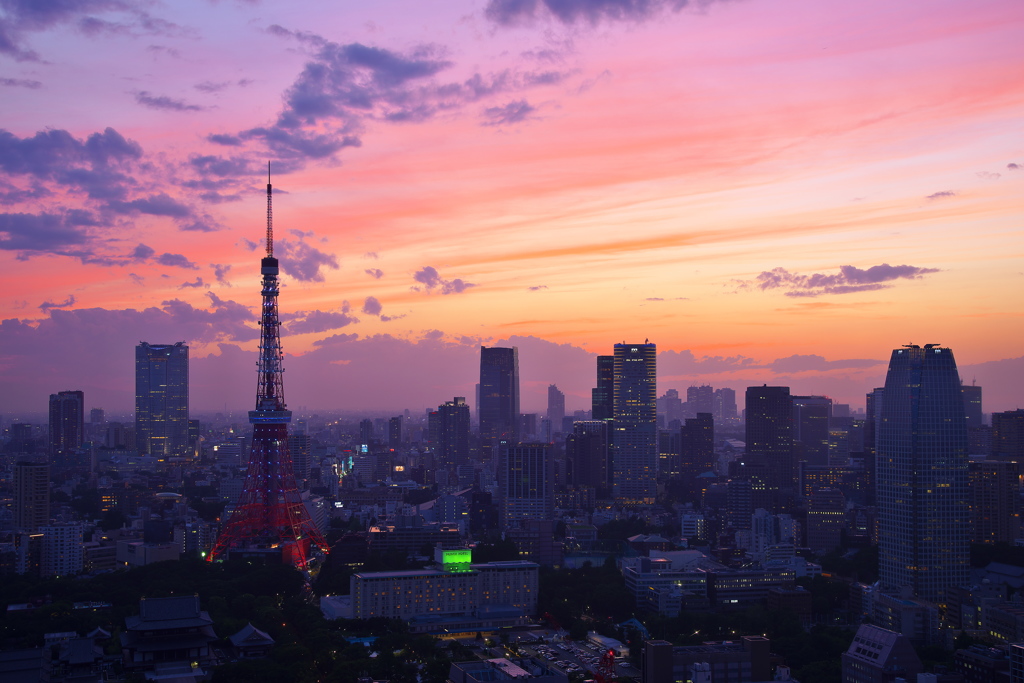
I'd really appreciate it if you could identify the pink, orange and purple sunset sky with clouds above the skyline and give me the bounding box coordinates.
[0,0,1024,418]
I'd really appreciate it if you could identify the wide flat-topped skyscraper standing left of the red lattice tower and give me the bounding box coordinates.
[135,342,188,458]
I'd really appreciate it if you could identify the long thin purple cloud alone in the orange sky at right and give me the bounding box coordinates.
[734,263,939,297]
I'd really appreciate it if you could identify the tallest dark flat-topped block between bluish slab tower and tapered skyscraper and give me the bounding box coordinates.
[745,385,797,507]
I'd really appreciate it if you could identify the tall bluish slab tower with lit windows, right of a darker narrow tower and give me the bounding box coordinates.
[611,343,657,505]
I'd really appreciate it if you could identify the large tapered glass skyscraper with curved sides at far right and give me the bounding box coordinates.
[878,344,971,602]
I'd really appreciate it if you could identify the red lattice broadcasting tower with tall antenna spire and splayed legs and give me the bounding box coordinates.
[209,172,329,572]
